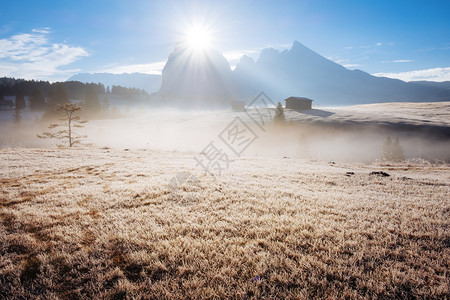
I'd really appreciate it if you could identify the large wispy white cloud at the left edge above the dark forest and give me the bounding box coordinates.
[0,27,89,81]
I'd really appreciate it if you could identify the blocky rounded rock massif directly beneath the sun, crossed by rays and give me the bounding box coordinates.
[159,43,235,106]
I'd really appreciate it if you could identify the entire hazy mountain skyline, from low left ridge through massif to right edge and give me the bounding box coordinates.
[70,41,450,106]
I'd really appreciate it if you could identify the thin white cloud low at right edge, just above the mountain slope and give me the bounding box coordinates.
[372,67,450,82]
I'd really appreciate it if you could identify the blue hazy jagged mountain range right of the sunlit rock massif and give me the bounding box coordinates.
[234,41,450,105]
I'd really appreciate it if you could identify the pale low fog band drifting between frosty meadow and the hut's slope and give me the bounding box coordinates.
[0,107,450,162]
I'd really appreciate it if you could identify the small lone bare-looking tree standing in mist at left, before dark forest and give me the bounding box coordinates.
[37,103,87,147]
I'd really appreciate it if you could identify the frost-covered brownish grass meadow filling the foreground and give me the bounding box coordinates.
[0,148,450,299]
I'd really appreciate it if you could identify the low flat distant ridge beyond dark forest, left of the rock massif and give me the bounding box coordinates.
[67,73,161,93]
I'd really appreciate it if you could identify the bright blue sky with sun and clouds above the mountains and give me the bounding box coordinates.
[0,0,450,81]
